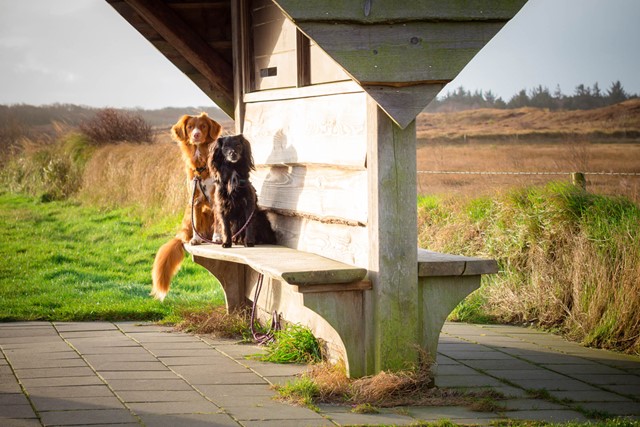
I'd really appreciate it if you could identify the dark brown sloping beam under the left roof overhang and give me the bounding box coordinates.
[125,0,234,114]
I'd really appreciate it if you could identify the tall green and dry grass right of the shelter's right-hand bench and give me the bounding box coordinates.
[419,183,640,354]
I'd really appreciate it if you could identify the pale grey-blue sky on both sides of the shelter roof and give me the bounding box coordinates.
[0,0,640,109]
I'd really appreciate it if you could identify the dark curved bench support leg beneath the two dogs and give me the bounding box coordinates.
[193,255,248,313]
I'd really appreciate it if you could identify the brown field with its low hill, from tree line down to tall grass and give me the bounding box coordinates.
[417,100,640,202]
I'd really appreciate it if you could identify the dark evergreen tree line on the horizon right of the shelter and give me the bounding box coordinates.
[426,80,638,113]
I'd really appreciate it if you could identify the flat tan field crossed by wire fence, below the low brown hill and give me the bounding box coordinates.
[417,141,640,202]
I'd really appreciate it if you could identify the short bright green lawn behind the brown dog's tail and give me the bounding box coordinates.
[0,193,224,322]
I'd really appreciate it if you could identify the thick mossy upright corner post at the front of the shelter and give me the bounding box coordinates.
[365,97,419,373]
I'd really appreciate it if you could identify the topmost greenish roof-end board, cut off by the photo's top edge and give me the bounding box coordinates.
[275,0,526,23]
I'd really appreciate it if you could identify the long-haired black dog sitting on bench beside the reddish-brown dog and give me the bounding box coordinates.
[208,135,276,248]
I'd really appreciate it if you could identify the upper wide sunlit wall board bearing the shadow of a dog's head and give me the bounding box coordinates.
[243,92,367,168]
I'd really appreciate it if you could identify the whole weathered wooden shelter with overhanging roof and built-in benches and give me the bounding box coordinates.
[107,0,526,376]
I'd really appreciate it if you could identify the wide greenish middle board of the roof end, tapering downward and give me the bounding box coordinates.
[301,22,504,84]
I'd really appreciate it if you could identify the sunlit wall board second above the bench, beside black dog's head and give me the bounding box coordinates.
[251,166,367,224]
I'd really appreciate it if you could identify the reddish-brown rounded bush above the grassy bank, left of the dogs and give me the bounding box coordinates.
[80,108,154,144]
